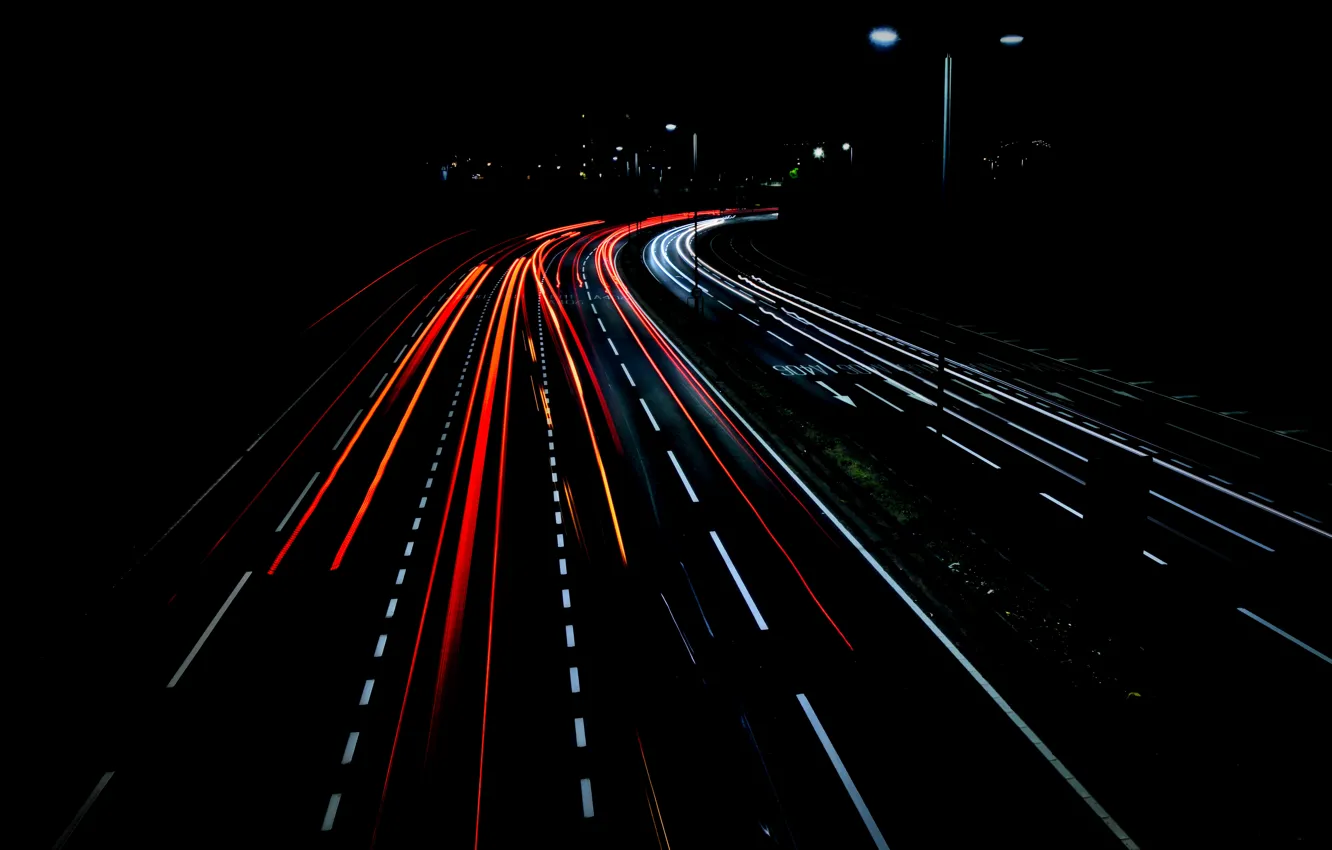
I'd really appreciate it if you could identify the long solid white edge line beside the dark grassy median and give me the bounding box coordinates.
[649,326,1139,850]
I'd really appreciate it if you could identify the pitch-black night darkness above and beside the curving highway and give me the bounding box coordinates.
[9,5,1327,626]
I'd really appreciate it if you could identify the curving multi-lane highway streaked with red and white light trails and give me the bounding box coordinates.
[39,211,1329,849]
